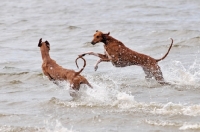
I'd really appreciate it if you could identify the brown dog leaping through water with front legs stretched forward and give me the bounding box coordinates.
[79,30,173,84]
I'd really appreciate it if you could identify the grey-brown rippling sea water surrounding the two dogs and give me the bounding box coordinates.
[0,0,200,132]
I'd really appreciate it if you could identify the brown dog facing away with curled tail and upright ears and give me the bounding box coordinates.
[38,38,92,90]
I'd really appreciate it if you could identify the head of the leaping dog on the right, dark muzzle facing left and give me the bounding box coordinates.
[91,30,110,45]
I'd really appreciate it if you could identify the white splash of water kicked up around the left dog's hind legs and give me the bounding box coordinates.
[50,75,135,107]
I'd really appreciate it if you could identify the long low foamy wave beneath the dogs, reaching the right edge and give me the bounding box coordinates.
[49,93,200,116]
